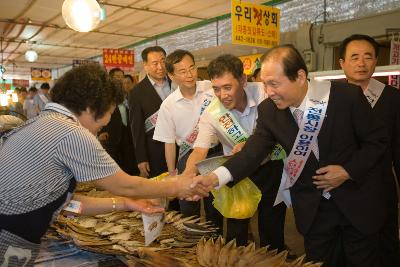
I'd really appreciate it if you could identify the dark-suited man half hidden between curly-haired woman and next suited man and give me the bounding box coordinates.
[99,68,139,175]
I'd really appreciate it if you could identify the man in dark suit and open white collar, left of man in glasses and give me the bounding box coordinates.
[128,46,171,177]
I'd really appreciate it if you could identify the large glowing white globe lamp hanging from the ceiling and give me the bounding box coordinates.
[62,0,101,32]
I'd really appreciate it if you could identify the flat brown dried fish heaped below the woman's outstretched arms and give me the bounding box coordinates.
[52,211,217,266]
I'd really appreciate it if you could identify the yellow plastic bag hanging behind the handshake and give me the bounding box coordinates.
[211,178,261,219]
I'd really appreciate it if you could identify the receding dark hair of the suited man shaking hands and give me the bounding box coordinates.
[261,44,308,81]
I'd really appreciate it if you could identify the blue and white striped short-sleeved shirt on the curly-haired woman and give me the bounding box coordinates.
[0,103,119,215]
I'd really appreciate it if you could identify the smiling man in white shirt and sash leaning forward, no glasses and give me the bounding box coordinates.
[184,55,286,250]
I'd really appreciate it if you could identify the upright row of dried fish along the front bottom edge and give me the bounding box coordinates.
[196,236,322,267]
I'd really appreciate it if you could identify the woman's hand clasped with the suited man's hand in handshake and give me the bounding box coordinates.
[176,175,210,200]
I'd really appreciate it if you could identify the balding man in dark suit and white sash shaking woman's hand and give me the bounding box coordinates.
[197,45,388,267]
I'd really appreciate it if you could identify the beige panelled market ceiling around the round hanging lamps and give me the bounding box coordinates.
[0,0,266,75]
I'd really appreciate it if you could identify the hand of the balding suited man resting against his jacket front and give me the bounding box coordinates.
[312,165,350,192]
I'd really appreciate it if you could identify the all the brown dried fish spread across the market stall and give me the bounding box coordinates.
[52,184,321,267]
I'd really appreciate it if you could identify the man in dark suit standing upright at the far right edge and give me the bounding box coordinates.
[339,34,400,266]
